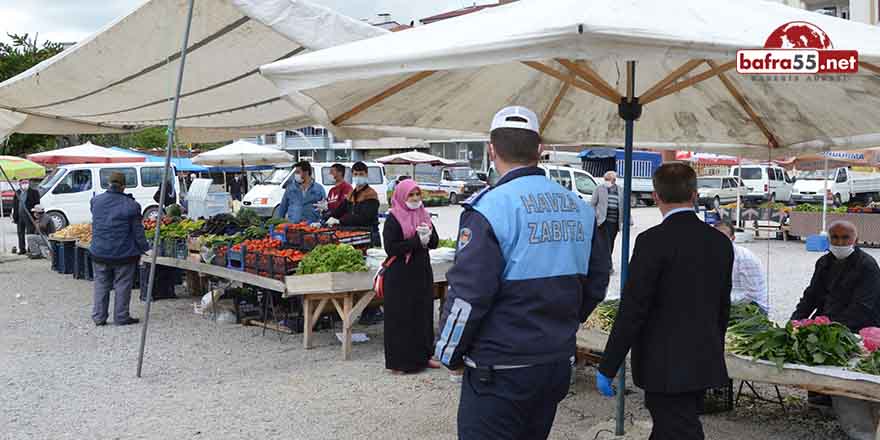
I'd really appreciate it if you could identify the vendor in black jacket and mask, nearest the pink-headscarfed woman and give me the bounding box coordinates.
[327,162,382,246]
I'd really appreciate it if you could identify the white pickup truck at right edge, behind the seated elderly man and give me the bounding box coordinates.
[791,168,880,206]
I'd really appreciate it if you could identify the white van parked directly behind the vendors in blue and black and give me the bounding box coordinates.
[241,162,388,217]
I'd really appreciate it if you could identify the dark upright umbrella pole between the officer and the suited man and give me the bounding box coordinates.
[615,61,642,435]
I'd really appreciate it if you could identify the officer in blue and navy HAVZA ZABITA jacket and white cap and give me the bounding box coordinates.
[435,107,610,440]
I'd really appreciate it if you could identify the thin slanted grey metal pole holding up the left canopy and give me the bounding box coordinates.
[137,0,195,377]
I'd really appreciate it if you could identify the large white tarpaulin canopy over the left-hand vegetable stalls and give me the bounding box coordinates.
[0,0,387,142]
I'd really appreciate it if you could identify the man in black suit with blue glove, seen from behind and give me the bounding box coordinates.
[596,163,734,440]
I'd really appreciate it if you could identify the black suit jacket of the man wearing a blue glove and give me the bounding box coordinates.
[599,212,733,393]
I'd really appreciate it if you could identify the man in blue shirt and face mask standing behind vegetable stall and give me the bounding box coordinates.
[278,161,327,224]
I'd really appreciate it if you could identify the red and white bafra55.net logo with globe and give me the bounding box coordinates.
[736,21,859,74]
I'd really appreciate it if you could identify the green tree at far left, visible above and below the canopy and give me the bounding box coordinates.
[0,34,64,156]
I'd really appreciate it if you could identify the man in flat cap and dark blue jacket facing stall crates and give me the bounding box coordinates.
[91,172,150,327]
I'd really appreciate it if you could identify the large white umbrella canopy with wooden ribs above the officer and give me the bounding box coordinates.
[261,0,880,157]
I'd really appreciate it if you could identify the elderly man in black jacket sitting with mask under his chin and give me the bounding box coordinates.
[791,221,880,332]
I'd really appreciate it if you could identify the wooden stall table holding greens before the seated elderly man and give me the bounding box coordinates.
[577,329,880,440]
